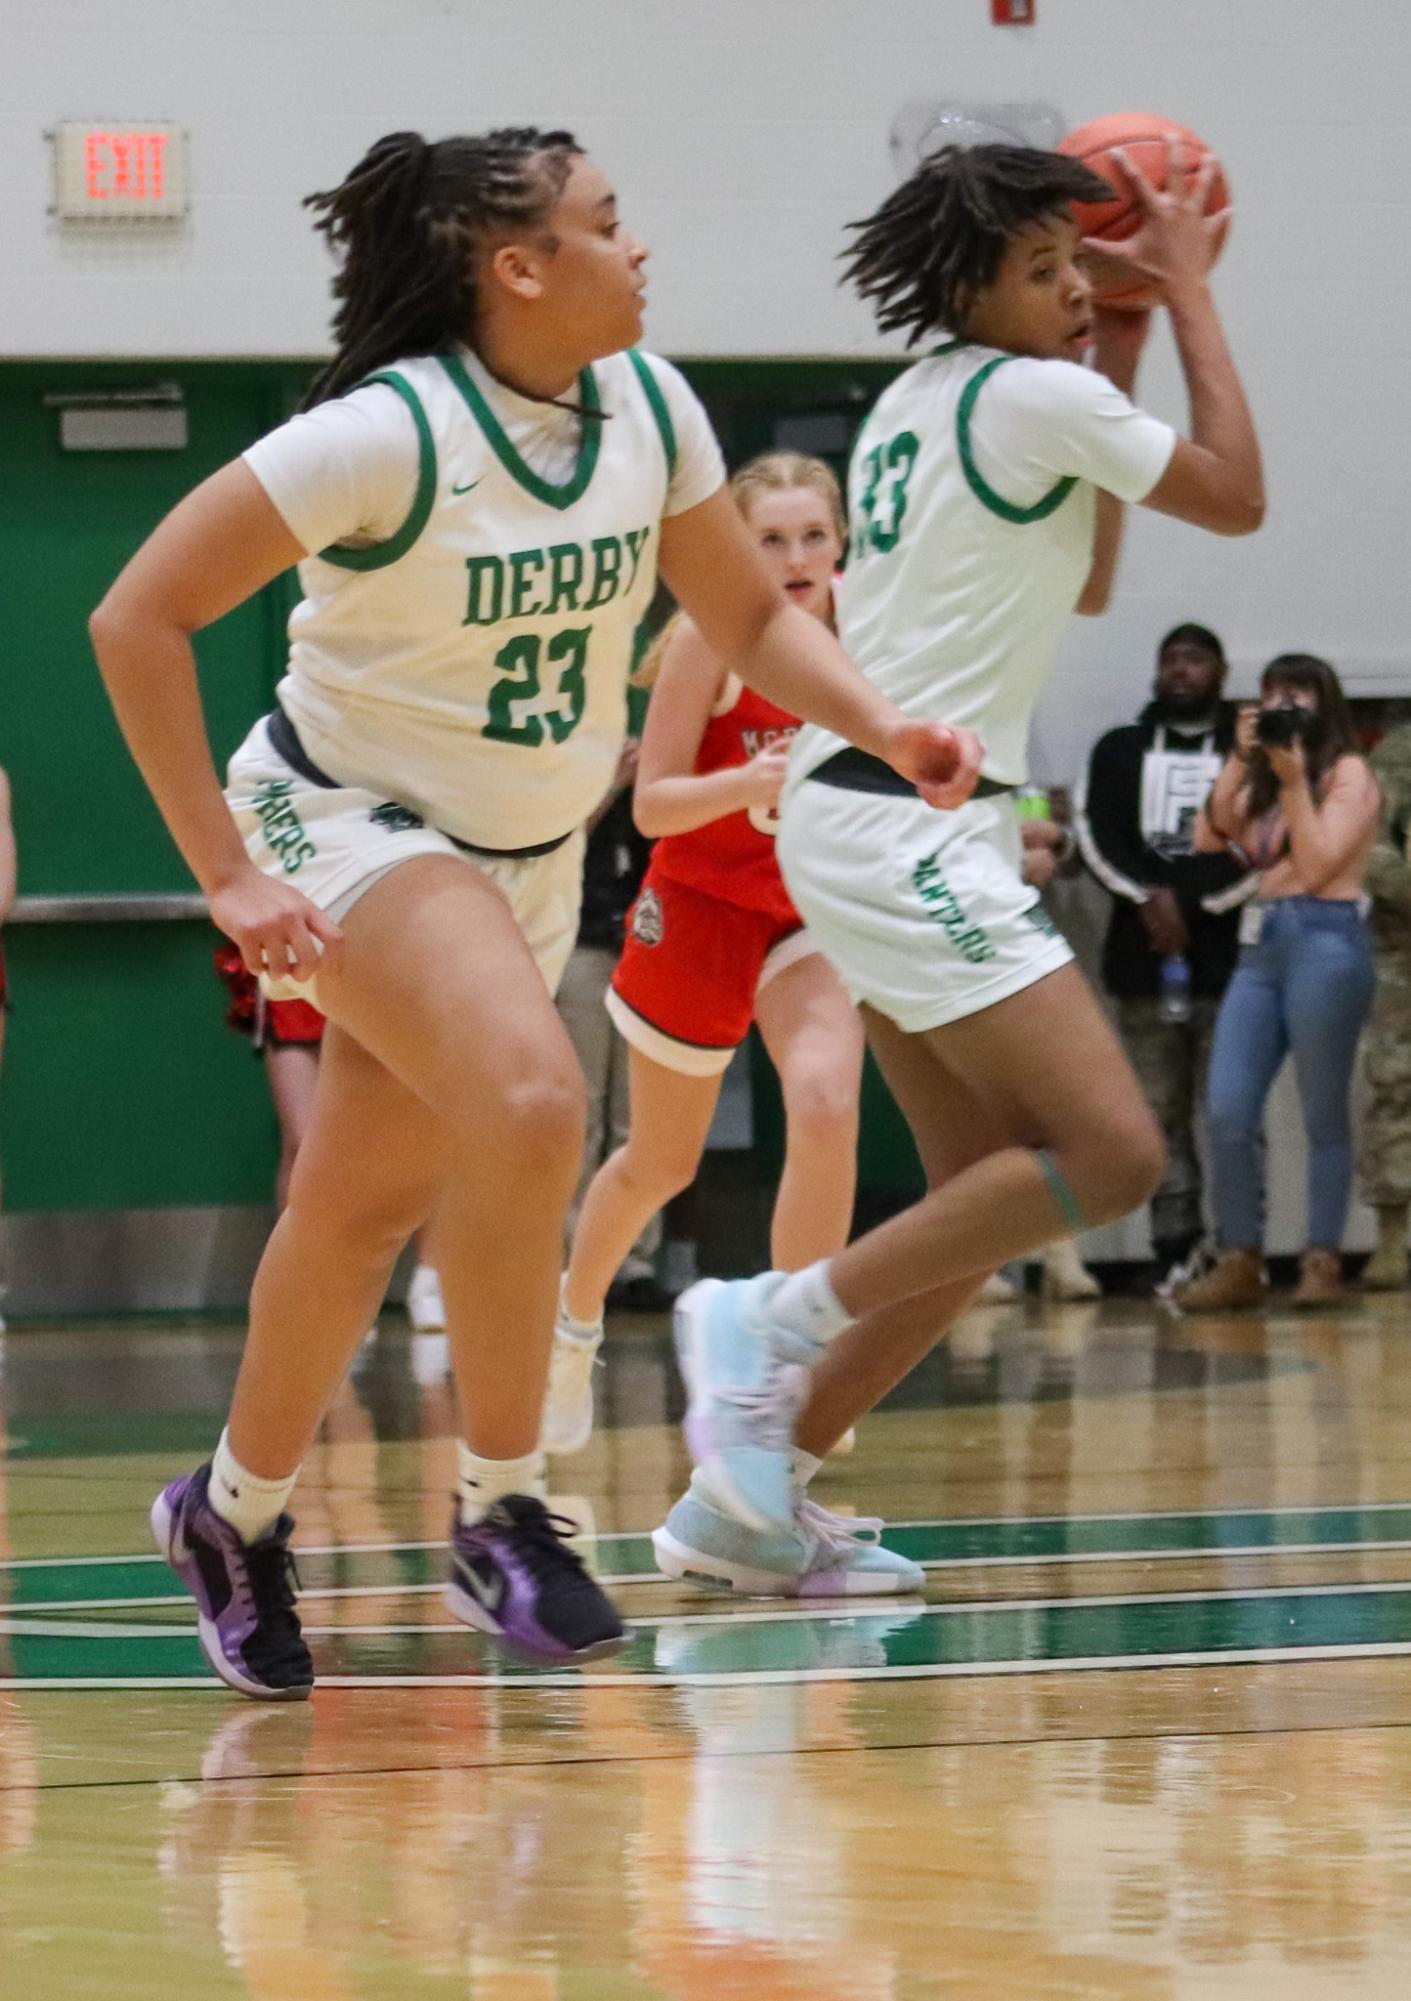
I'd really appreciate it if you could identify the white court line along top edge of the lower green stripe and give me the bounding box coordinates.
[11,1581,1411,1639]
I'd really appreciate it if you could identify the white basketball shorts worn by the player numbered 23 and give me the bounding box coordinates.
[226,720,584,1007]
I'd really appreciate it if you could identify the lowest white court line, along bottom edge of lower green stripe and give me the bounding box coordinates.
[0,1639,1411,1695]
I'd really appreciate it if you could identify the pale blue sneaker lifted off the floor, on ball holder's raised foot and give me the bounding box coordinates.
[674,1273,809,1535]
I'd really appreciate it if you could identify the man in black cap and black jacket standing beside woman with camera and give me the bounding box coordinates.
[1077,624,1255,1285]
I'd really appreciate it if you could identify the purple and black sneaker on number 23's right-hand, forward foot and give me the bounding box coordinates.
[446,1495,622,1667]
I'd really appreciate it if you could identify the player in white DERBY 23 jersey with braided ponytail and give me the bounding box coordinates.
[92,128,979,1701]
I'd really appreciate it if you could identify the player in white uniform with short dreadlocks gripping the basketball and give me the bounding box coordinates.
[664,146,1263,1569]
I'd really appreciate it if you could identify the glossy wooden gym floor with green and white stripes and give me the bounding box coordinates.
[0,1299,1411,2001]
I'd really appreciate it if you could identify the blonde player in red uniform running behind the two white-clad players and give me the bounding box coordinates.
[542,452,919,1591]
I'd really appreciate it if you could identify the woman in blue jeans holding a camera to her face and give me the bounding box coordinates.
[1177,652,1379,1311]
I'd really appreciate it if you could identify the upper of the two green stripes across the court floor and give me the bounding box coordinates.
[0,1503,1411,1609]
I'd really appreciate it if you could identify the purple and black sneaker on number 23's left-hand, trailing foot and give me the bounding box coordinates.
[152,1467,314,1703]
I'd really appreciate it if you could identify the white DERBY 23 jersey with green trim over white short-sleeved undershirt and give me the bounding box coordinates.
[244,348,725,850]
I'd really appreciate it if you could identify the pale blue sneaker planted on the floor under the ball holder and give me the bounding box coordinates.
[652,1475,927,1599]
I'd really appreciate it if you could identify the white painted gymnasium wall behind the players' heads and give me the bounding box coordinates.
[0,0,1411,780]
